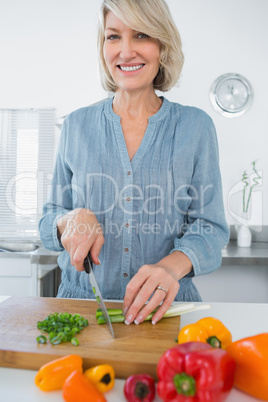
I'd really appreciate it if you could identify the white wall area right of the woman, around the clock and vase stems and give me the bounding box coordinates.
[167,0,268,229]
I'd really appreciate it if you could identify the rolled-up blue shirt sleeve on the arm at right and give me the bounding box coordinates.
[171,118,229,277]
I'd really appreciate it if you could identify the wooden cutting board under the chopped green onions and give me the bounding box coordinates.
[0,297,180,379]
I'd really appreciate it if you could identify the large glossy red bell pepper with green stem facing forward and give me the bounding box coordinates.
[157,342,235,402]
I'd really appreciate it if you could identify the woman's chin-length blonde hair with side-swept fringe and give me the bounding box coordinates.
[98,0,184,92]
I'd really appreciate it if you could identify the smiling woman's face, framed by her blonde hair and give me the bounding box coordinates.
[103,11,160,92]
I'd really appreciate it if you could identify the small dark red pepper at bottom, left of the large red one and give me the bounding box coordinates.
[124,374,155,402]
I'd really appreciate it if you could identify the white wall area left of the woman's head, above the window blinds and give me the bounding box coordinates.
[0,0,106,116]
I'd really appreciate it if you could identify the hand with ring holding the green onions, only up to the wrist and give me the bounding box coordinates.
[124,264,180,324]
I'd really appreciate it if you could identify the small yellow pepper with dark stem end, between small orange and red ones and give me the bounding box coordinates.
[84,364,115,392]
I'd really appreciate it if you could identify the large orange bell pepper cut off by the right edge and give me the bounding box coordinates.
[226,332,268,401]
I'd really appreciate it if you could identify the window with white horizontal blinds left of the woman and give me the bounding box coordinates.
[0,108,56,241]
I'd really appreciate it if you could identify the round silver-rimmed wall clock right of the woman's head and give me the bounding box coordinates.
[210,73,253,117]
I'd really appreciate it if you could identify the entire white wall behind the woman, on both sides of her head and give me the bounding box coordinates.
[0,0,268,225]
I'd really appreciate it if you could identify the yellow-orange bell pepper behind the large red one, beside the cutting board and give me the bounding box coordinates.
[178,317,232,349]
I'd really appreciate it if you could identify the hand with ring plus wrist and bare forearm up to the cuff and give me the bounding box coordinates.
[123,251,193,324]
